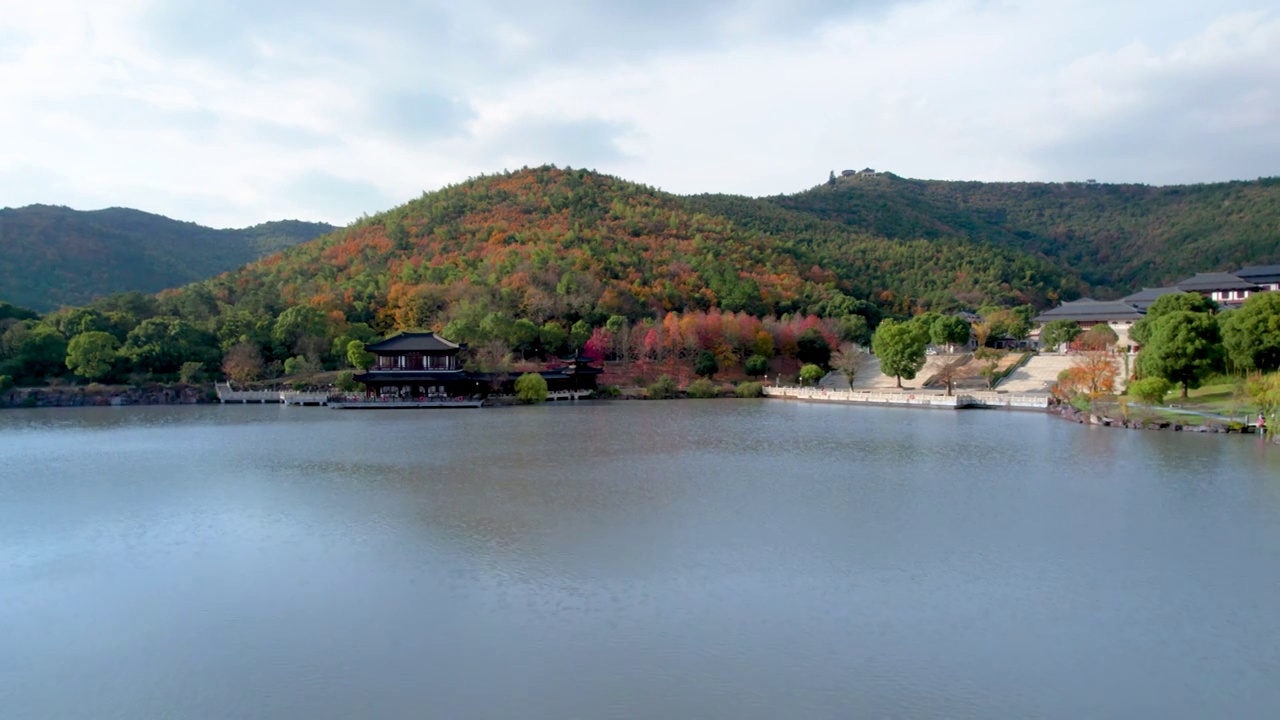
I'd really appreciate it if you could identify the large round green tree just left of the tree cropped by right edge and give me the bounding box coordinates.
[1138,310,1224,397]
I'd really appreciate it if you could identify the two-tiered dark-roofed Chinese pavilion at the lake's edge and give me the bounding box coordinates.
[355,333,488,398]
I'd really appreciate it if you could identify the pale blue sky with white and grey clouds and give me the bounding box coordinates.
[0,0,1280,227]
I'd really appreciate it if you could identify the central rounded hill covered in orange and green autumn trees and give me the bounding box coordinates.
[180,168,1079,328]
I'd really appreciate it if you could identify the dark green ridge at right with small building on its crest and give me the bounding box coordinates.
[769,173,1280,296]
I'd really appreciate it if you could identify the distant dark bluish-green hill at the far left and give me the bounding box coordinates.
[0,205,334,310]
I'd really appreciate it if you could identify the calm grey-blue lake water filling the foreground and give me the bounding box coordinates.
[0,401,1280,720]
